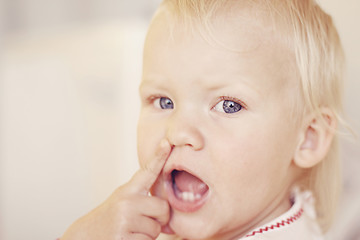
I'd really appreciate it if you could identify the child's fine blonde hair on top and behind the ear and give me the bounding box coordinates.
[156,0,344,231]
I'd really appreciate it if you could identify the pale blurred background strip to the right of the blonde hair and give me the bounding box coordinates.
[320,0,360,240]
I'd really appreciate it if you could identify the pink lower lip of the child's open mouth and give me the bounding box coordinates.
[165,176,209,212]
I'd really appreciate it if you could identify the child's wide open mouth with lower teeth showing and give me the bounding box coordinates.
[167,169,209,212]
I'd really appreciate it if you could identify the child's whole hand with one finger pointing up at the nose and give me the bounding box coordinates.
[61,140,171,240]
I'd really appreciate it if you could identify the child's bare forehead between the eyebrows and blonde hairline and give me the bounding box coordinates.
[144,1,298,97]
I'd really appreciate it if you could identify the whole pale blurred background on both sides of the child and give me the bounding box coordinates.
[0,0,360,240]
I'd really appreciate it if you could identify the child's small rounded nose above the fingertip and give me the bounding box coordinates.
[166,110,204,151]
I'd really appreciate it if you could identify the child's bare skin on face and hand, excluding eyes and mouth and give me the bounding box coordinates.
[61,3,312,240]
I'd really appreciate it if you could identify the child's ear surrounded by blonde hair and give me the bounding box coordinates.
[294,108,337,168]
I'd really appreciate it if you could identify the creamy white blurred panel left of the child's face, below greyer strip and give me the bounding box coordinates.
[0,21,146,240]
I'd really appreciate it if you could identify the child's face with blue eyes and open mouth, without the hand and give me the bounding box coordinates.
[138,7,300,239]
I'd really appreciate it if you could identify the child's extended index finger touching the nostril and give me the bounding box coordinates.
[131,139,171,194]
